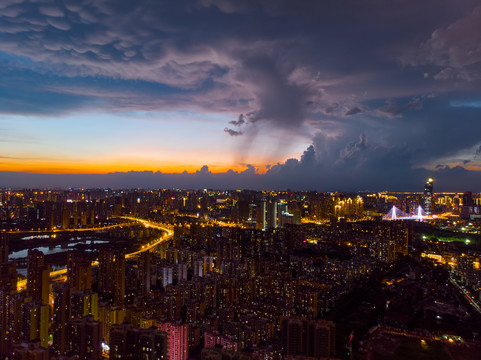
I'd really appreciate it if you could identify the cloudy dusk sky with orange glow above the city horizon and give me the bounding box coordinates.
[0,0,481,192]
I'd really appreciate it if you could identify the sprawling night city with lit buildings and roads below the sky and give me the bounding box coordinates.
[0,187,481,360]
